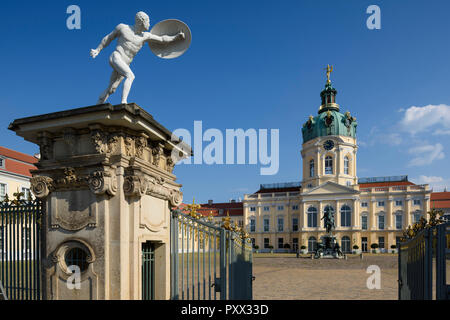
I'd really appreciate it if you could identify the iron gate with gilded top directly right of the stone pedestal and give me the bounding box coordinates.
[171,210,253,300]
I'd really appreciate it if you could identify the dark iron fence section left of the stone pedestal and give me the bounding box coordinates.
[0,194,43,300]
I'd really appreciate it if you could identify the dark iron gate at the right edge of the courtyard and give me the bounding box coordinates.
[398,222,450,300]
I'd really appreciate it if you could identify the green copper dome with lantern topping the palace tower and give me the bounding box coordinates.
[302,81,357,143]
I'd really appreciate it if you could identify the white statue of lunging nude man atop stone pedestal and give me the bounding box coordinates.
[91,11,185,104]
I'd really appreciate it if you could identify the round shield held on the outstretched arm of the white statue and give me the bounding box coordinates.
[148,19,191,59]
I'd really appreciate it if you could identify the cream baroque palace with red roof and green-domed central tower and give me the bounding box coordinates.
[243,74,432,252]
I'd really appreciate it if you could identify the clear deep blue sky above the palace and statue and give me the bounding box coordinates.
[0,0,450,202]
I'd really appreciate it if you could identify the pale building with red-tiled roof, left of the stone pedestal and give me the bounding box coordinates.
[0,147,38,200]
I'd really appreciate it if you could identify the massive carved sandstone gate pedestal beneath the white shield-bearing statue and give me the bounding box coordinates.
[9,103,190,299]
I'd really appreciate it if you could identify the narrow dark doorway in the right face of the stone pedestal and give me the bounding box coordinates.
[142,241,155,300]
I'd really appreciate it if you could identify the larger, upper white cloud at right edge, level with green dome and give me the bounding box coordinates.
[400,104,450,135]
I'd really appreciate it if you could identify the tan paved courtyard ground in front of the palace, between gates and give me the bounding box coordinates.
[253,254,398,300]
